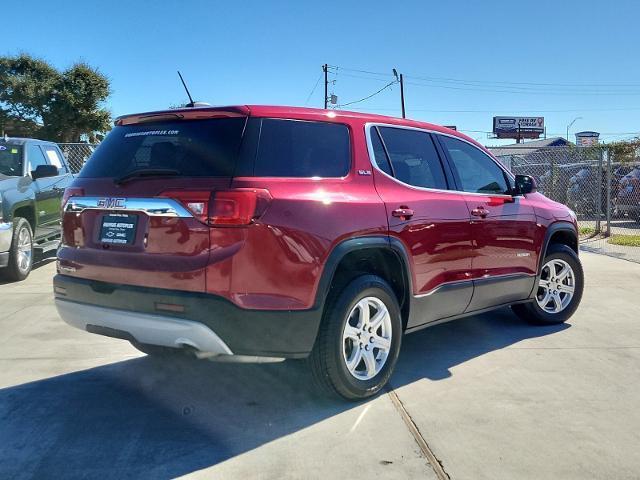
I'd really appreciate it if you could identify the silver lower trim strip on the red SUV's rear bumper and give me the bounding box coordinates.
[55,298,233,356]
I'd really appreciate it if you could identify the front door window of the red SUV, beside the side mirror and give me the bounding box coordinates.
[440,135,509,194]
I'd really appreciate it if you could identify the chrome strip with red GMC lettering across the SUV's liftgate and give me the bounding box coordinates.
[64,197,193,218]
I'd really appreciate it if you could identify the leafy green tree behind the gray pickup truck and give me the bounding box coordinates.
[0,54,111,142]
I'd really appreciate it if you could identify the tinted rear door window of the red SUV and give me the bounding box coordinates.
[379,127,447,189]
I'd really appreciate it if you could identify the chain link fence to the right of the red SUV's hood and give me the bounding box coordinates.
[490,143,640,263]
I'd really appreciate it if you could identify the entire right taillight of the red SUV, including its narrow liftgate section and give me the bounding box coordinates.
[161,188,271,226]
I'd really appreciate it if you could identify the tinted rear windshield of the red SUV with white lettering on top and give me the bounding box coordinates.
[80,117,246,178]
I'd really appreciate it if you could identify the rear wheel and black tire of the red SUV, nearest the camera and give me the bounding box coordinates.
[308,275,403,400]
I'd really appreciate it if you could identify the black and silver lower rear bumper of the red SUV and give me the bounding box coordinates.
[53,274,321,358]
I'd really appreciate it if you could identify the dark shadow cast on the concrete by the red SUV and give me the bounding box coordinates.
[0,311,567,479]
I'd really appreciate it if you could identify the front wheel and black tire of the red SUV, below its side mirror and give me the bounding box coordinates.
[511,244,584,325]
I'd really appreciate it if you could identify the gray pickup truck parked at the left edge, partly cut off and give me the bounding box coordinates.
[0,137,73,281]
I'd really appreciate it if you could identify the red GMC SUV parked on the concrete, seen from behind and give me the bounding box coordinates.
[54,106,583,399]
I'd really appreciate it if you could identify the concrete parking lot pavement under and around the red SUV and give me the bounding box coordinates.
[0,252,640,479]
